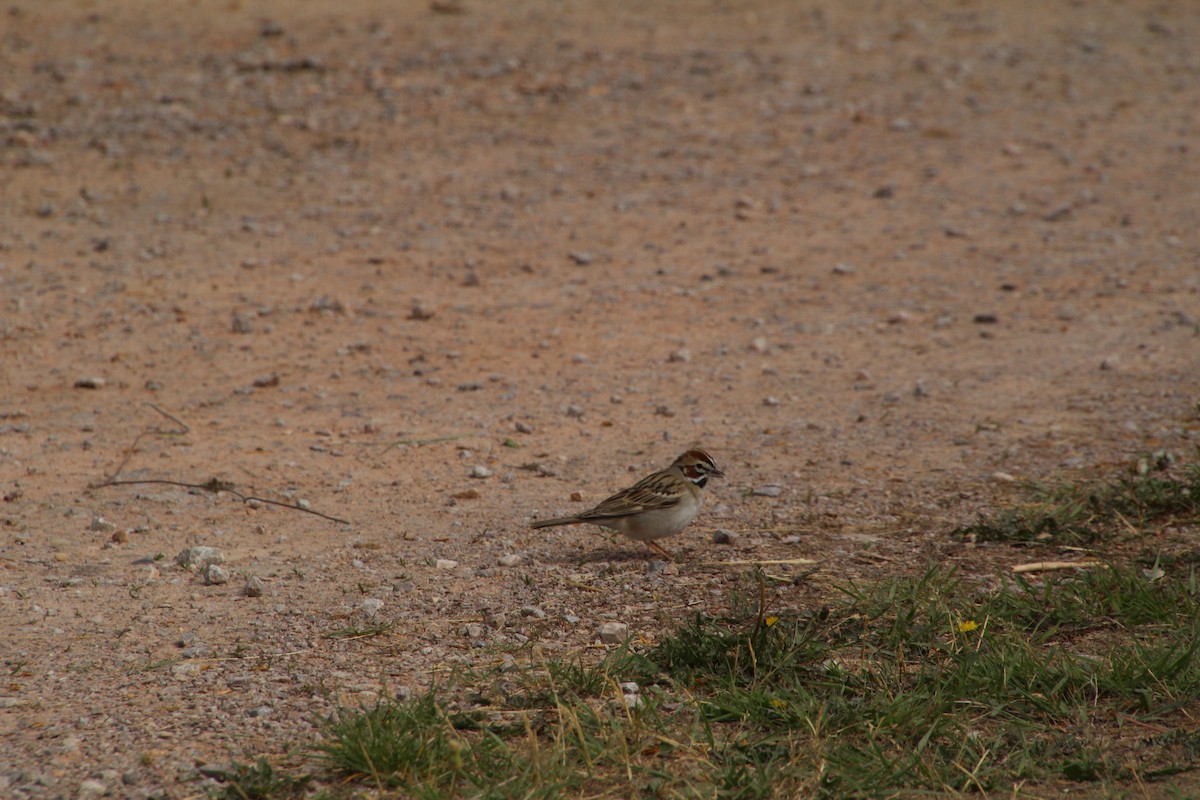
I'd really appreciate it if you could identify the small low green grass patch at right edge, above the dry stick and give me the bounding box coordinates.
[958,453,1200,545]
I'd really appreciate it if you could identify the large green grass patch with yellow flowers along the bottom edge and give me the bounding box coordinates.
[290,565,1200,798]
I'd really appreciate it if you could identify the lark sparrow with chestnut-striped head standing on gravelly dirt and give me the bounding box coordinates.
[529,450,725,558]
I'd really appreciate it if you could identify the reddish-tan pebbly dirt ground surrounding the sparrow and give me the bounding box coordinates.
[0,0,1200,798]
